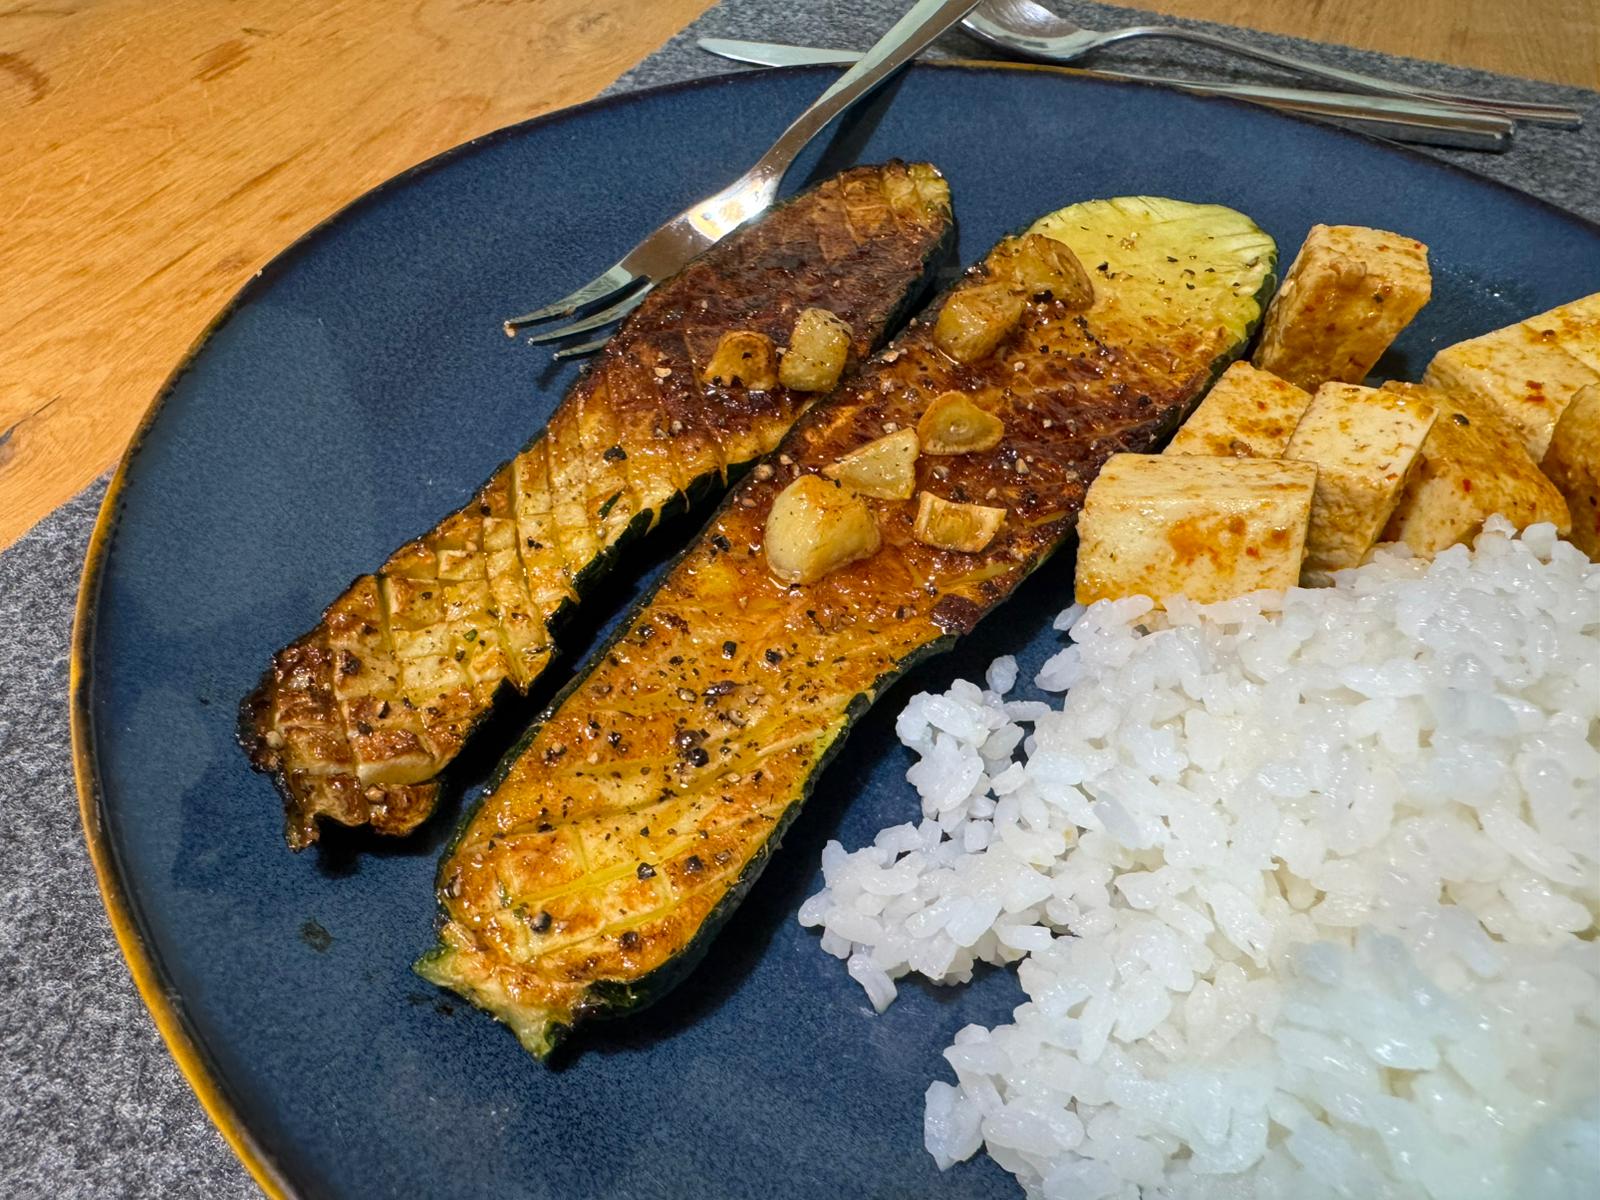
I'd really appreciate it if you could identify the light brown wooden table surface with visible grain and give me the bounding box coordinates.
[0,0,1600,547]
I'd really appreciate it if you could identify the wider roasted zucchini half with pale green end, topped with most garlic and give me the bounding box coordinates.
[418,197,1275,1056]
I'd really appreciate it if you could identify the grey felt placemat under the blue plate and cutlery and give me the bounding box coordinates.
[0,0,1600,1200]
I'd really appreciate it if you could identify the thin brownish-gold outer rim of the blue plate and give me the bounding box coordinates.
[67,58,1600,1200]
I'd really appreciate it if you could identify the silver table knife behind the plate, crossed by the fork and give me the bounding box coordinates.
[698,37,1514,154]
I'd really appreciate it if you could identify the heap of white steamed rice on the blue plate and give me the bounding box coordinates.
[800,520,1600,1200]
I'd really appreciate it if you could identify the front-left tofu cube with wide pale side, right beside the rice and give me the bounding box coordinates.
[1077,454,1317,605]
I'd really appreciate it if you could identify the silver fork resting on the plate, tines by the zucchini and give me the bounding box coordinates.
[506,0,978,358]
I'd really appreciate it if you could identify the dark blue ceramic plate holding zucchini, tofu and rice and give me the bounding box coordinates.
[74,67,1600,1200]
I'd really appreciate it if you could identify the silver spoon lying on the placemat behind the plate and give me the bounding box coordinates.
[963,0,1584,130]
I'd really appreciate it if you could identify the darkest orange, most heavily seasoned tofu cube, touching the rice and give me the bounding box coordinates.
[1382,384,1571,557]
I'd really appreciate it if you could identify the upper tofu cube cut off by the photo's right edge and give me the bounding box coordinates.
[1422,293,1600,462]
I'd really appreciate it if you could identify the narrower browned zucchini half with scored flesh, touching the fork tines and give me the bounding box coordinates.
[240,162,952,850]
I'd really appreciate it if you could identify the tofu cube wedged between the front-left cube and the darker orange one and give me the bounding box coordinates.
[1283,384,1435,587]
